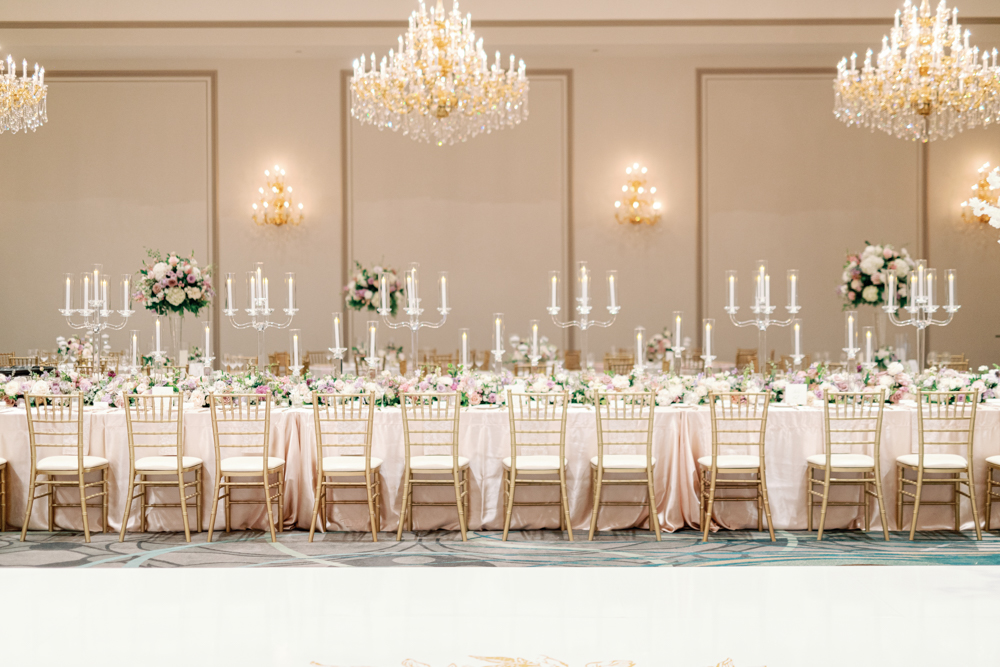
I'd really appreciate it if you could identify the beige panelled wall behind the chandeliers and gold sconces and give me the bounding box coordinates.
[0,26,1000,363]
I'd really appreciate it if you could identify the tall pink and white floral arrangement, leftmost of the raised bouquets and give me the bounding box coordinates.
[133,250,215,316]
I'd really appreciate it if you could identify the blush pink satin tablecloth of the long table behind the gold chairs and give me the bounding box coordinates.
[0,405,1000,531]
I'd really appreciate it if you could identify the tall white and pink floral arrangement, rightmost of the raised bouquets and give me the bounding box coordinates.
[838,241,917,309]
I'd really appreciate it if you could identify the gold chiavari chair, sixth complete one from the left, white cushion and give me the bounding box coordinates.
[503,389,573,542]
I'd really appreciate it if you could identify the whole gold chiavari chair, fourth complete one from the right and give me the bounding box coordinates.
[588,392,660,542]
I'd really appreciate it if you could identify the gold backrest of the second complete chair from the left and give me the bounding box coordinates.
[125,395,184,474]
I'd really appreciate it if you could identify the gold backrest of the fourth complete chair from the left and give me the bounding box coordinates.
[313,392,375,473]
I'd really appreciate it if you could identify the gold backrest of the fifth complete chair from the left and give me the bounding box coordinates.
[400,392,461,471]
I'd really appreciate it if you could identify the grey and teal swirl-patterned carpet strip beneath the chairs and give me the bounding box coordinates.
[0,530,1000,567]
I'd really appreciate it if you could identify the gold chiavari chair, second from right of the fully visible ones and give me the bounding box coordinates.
[806,389,889,542]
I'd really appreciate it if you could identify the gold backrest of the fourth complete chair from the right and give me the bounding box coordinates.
[596,391,656,470]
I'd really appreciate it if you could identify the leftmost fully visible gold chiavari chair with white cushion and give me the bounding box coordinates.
[21,394,108,542]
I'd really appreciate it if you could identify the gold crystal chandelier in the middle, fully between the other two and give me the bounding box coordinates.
[351,0,528,146]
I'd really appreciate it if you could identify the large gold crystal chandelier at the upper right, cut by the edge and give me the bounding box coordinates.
[833,0,1000,142]
